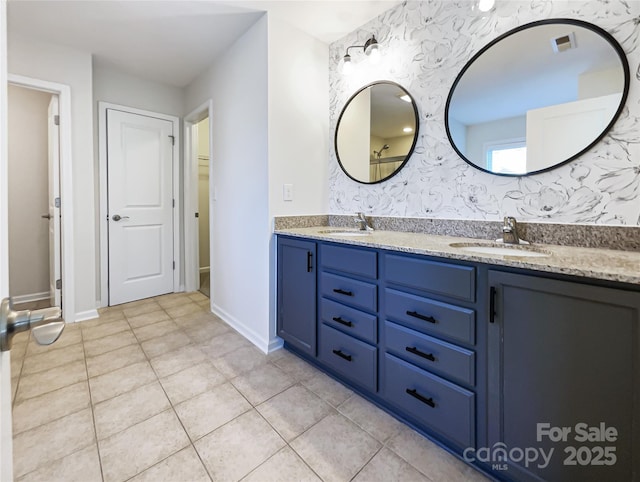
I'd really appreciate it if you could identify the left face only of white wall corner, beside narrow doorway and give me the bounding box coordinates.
[185,17,270,351]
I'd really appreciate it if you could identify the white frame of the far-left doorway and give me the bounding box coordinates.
[7,74,76,323]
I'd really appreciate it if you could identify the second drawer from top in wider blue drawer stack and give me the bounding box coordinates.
[384,288,476,345]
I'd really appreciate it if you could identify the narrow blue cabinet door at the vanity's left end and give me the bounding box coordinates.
[278,238,316,356]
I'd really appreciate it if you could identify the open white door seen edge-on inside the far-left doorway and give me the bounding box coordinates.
[48,95,62,306]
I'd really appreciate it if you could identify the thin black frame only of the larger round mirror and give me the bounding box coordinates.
[444,18,631,177]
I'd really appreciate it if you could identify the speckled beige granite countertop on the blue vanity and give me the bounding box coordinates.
[275,226,640,285]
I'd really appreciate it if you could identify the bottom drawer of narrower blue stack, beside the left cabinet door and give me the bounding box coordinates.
[318,324,378,392]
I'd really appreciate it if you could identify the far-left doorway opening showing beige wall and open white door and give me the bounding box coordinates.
[8,84,62,309]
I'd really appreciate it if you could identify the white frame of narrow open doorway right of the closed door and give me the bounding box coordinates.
[183,99,213,292]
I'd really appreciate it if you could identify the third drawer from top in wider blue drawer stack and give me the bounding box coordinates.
[384,321,476,385]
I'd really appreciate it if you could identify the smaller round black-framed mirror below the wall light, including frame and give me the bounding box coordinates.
[335,82,418,184]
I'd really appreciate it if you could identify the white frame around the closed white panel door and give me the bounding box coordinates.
[98,101,184,307]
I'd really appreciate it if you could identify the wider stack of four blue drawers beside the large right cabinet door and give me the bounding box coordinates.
[380,252,478,452]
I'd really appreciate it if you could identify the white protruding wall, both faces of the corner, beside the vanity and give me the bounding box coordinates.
[185,16,329,351]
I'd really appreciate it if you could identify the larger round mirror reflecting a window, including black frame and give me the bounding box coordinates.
[445,19,629,176]
